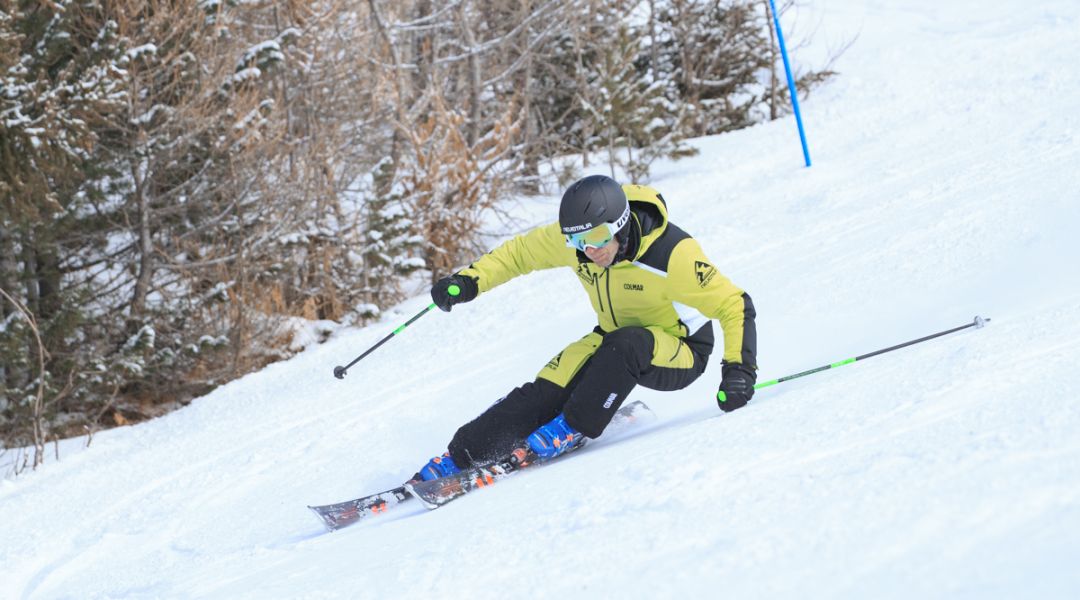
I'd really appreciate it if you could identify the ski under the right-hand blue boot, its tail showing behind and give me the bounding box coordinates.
[404,400,652,509]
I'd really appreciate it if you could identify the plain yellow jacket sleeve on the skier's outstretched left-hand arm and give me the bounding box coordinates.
[460,222,578,294]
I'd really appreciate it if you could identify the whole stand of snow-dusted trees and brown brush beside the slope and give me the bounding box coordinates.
[0,0,829,447]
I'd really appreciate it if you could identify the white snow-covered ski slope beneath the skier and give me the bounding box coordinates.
[6,0,1080,599]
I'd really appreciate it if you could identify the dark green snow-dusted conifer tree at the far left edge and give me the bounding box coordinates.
[0,2,124,445]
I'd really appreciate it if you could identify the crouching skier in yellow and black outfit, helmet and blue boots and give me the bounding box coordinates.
[418,175,757,480]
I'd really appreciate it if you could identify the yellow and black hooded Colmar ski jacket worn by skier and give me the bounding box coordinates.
[460,185,757,370]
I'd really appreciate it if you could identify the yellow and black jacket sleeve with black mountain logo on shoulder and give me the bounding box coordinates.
[667,237,757,370]
